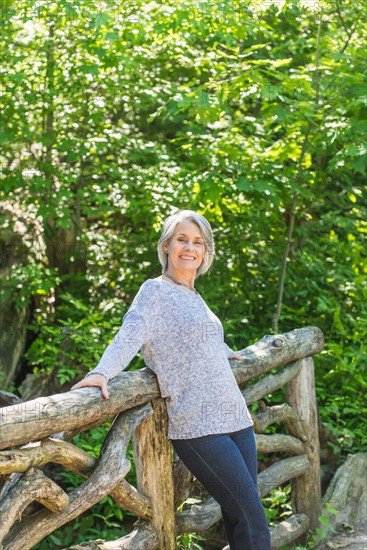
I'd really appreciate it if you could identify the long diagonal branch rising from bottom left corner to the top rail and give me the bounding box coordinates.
[4,404,152,550]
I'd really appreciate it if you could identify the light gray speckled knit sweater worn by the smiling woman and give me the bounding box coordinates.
[88,278,253,439]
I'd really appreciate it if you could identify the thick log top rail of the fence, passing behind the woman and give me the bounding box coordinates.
[0,327,324,449]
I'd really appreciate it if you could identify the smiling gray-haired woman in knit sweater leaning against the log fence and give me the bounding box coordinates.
[72,210,271,550]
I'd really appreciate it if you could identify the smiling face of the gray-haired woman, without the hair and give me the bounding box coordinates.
[166,221,205,273]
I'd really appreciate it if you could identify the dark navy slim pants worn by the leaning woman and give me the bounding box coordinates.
[171,427,271,550]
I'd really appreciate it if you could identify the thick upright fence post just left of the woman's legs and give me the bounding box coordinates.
[133,398,176,550]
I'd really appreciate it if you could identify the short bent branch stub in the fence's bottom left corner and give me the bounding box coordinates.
[0,468,69,542]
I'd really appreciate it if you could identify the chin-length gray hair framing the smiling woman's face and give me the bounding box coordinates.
[157,210,215,279]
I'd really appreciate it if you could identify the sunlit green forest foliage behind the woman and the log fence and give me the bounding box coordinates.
[0,0,367,549]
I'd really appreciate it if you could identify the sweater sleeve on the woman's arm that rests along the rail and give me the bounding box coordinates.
[87,279,158,381]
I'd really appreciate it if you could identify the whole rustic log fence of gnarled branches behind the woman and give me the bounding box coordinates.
[0,327,324,550]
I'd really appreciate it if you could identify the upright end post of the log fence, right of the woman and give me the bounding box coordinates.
[286,357,321,529]
